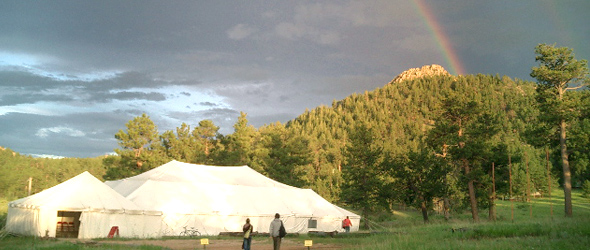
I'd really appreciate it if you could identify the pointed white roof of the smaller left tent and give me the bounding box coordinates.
[9,171,142,211]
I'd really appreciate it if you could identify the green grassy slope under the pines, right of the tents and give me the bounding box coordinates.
[338,189,590,250]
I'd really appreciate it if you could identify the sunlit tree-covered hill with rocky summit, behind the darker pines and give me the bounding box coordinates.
[286,65,545,203]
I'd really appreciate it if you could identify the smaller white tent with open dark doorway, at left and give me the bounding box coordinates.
[6,172,162,238]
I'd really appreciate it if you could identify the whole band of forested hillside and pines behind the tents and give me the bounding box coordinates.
[0,56,590,223]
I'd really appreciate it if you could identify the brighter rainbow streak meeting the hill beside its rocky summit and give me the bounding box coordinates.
[413,0,465,75]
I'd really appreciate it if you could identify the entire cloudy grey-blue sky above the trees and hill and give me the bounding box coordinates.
[0,0,590,158]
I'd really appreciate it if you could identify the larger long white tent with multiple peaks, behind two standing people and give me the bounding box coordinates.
[106,161,360,235]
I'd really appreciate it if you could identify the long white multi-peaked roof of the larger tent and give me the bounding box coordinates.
[106,161,356,217]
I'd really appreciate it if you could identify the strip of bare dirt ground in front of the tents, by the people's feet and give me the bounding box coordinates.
[69,238,342,250]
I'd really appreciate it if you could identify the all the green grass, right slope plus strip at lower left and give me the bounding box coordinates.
[0,191,590,250]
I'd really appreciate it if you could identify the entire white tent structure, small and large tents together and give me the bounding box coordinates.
[6,161,360,239]
